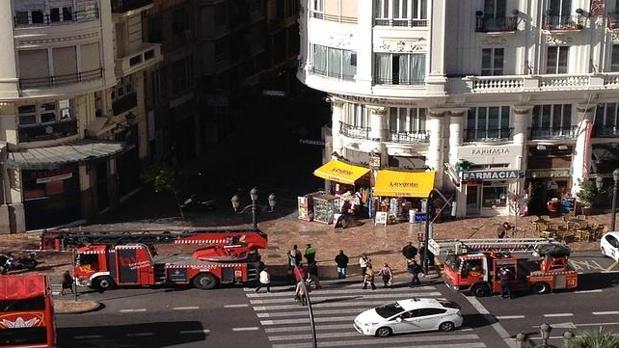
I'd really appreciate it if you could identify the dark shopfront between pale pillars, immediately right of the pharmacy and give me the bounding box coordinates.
[525,145,573,214]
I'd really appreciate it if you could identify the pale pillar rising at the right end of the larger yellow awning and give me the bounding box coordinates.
[426,109,445,188]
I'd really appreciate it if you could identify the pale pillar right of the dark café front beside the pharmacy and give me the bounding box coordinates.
[572,103,596,194]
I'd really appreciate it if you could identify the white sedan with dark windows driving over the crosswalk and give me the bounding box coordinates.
[354,298,463,337]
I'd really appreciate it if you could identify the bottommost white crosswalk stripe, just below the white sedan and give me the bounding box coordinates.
[273,334,479,348]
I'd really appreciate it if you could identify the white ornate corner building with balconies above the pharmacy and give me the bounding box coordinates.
[298,0,619,217]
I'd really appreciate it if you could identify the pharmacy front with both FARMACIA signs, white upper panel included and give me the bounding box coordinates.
[454,144,524,217]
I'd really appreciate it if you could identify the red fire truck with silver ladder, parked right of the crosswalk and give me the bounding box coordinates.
[428,238,578,297]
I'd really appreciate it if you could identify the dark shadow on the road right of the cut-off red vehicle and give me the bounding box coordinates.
[57,321,208,348]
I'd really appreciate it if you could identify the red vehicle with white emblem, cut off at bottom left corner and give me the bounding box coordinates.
[0,274,56,348]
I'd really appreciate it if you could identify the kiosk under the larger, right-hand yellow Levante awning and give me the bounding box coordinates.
[373,169,436,221]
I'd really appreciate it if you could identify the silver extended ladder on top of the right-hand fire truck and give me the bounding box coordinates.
[428,238,564,255]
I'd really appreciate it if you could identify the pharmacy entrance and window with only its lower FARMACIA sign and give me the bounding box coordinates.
[460,170,524,216]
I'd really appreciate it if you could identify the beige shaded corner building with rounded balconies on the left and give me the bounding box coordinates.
[0,0,162,233]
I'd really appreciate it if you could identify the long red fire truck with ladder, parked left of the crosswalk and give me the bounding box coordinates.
[41,228,267,290]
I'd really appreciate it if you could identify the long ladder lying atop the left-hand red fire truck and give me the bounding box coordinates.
[41,227,266,250]
